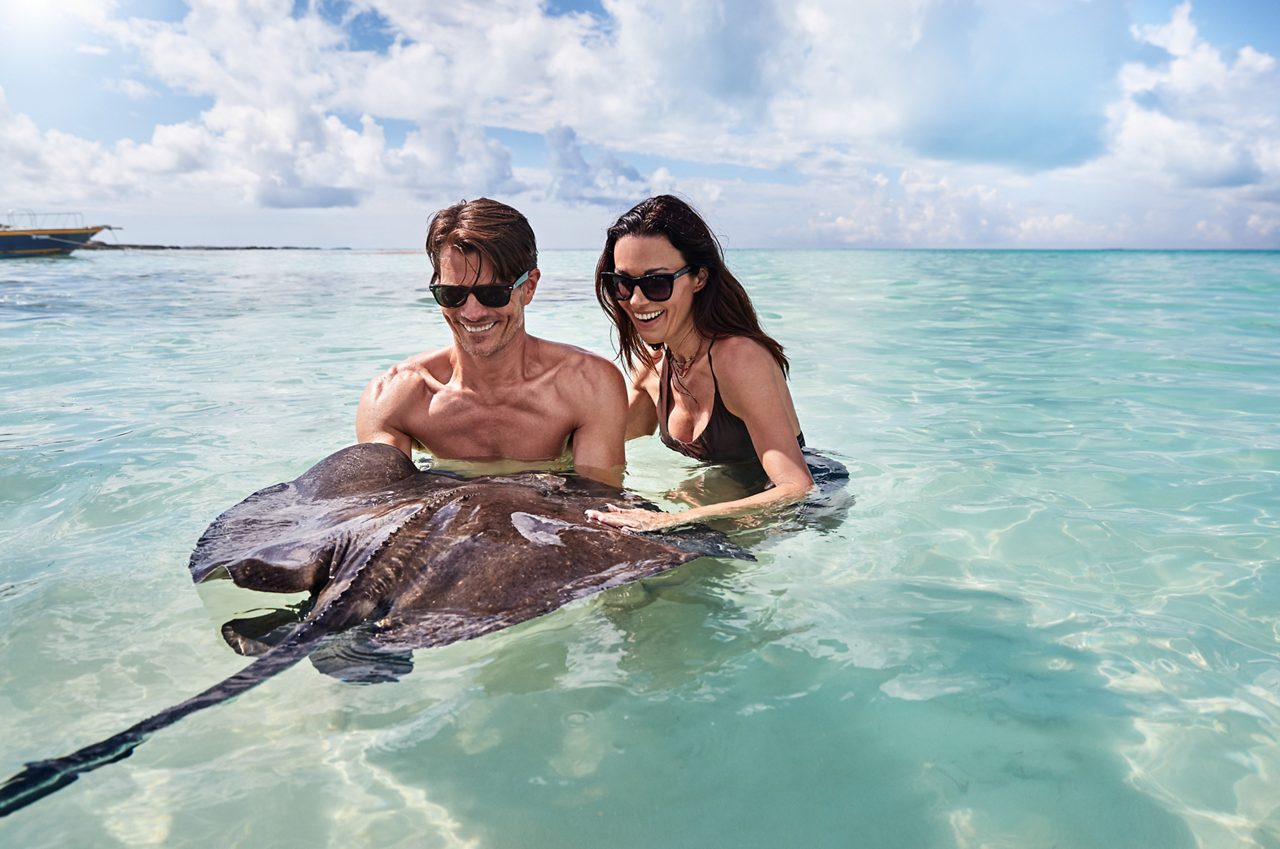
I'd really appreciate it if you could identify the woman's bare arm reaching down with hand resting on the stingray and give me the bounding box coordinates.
[588,337,813,530]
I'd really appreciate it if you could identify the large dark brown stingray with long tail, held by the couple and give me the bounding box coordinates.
[0,444,753,816]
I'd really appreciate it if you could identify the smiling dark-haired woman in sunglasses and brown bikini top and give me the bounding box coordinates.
[588,195,813,530]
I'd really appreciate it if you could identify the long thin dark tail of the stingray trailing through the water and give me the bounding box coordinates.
[0,629,317,817]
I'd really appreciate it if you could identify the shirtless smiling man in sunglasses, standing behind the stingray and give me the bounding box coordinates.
[356,198,627,485]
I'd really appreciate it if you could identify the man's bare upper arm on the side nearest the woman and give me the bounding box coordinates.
[572,356,627,487]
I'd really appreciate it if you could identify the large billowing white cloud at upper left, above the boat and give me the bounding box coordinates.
[4,0,520,209]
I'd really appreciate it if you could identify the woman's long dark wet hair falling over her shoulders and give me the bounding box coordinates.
[595,195,791,374]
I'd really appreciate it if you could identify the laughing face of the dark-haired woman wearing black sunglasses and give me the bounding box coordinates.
[613,236,707,344]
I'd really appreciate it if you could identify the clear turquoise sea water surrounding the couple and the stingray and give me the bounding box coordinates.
[0,251,1280,849]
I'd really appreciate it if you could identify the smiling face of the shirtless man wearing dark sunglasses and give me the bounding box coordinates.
[439,250,538,357]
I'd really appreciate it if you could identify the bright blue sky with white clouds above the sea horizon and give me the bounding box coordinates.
[0,0,1280,250]
